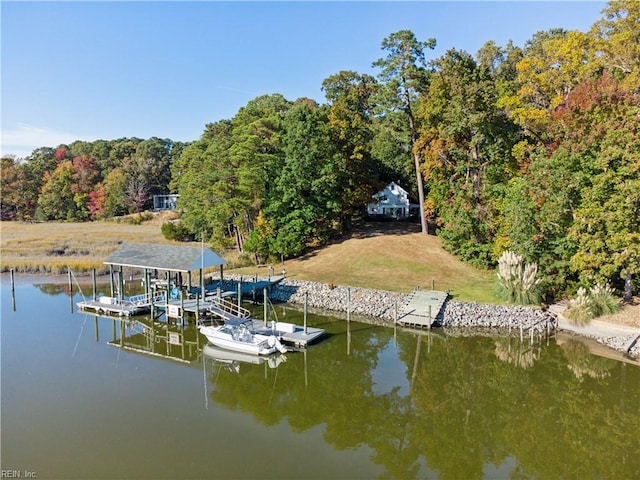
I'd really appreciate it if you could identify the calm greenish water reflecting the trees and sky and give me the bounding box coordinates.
[1,282,640,479]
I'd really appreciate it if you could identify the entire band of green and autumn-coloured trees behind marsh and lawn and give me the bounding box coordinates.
[2,0,640,295]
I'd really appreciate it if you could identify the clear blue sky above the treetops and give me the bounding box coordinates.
[0,0,606,157]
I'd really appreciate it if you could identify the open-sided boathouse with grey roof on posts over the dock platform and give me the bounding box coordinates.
[83,243,226,319]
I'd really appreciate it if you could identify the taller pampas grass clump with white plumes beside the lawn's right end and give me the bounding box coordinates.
[497,250,540,304]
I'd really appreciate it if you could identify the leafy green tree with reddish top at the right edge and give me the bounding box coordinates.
[557,75,640,297]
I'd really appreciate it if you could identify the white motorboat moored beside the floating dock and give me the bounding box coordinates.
[198,318,288,355]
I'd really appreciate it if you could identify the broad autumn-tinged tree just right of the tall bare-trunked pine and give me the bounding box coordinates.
[418,50,517,265]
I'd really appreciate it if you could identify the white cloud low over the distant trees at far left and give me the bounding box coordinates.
[0,123,91,158]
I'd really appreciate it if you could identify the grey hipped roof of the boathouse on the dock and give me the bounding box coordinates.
[104,243,227,272]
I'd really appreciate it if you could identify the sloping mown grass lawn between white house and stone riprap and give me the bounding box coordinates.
[232,223,498,303]
